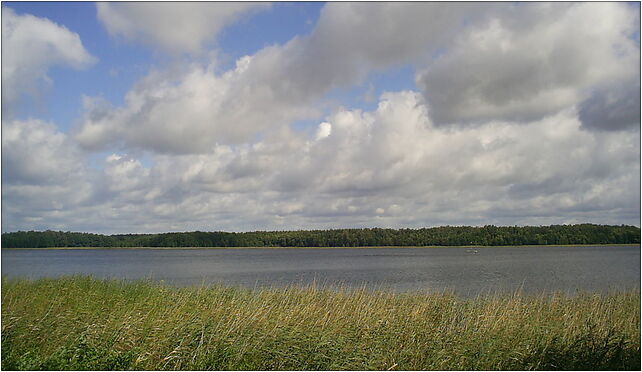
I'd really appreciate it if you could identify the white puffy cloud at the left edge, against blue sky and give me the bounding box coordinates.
[2,7,96,110]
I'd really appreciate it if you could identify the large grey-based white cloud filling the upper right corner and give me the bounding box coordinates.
[417,3,640,126]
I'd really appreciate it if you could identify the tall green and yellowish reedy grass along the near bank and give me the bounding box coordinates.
[2,277,640,370]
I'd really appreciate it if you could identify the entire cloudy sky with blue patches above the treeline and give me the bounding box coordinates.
[2,2,640,233]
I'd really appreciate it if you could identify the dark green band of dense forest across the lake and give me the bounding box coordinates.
[2,224,640,248]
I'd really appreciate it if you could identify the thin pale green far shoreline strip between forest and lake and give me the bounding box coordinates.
[2,243,640,250]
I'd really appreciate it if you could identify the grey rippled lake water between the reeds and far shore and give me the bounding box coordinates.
[2,245,640,296]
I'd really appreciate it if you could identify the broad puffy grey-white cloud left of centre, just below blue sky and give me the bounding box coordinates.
[76,57,318,153]
